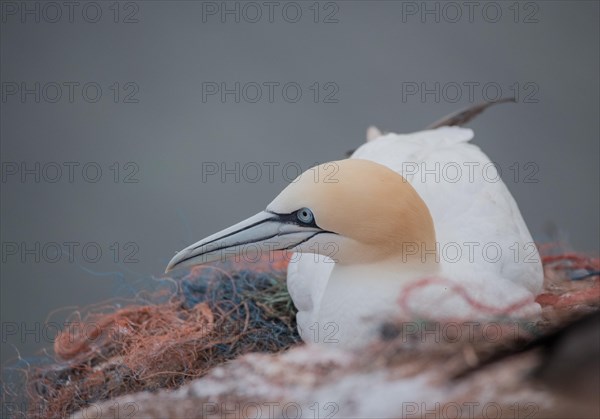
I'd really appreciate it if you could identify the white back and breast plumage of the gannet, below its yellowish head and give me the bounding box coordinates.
[288,127,543,348]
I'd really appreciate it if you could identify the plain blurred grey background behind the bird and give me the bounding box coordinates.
[0,1,600,366]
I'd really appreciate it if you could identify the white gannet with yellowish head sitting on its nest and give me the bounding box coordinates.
[167,127,543,348]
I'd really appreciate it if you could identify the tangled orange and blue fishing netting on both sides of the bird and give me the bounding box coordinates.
[2,245,600,417]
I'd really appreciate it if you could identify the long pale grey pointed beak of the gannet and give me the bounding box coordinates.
[165,211,323,273]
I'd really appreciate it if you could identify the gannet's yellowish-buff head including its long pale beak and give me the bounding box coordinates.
[167,159,435,272]
